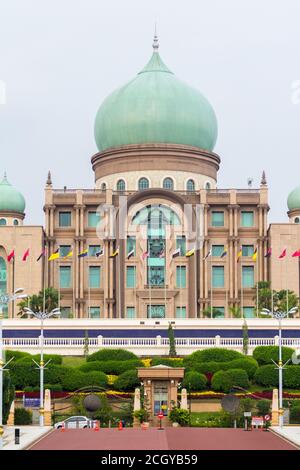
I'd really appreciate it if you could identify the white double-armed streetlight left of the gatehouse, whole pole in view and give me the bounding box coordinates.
[23,307,61,426]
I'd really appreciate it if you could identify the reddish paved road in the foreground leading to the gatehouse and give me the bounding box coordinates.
[31,428,296,450]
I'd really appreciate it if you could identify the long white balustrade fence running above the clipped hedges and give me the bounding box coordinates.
[3,336,300,356]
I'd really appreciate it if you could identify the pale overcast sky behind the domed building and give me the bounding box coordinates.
[0,0,300,224]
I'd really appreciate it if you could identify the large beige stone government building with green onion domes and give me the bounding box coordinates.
[0,36,300,325]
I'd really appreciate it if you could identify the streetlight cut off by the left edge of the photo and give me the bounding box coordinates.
[0,287,28,449]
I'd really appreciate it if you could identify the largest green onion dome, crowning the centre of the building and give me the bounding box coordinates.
[95,44,218,151]
